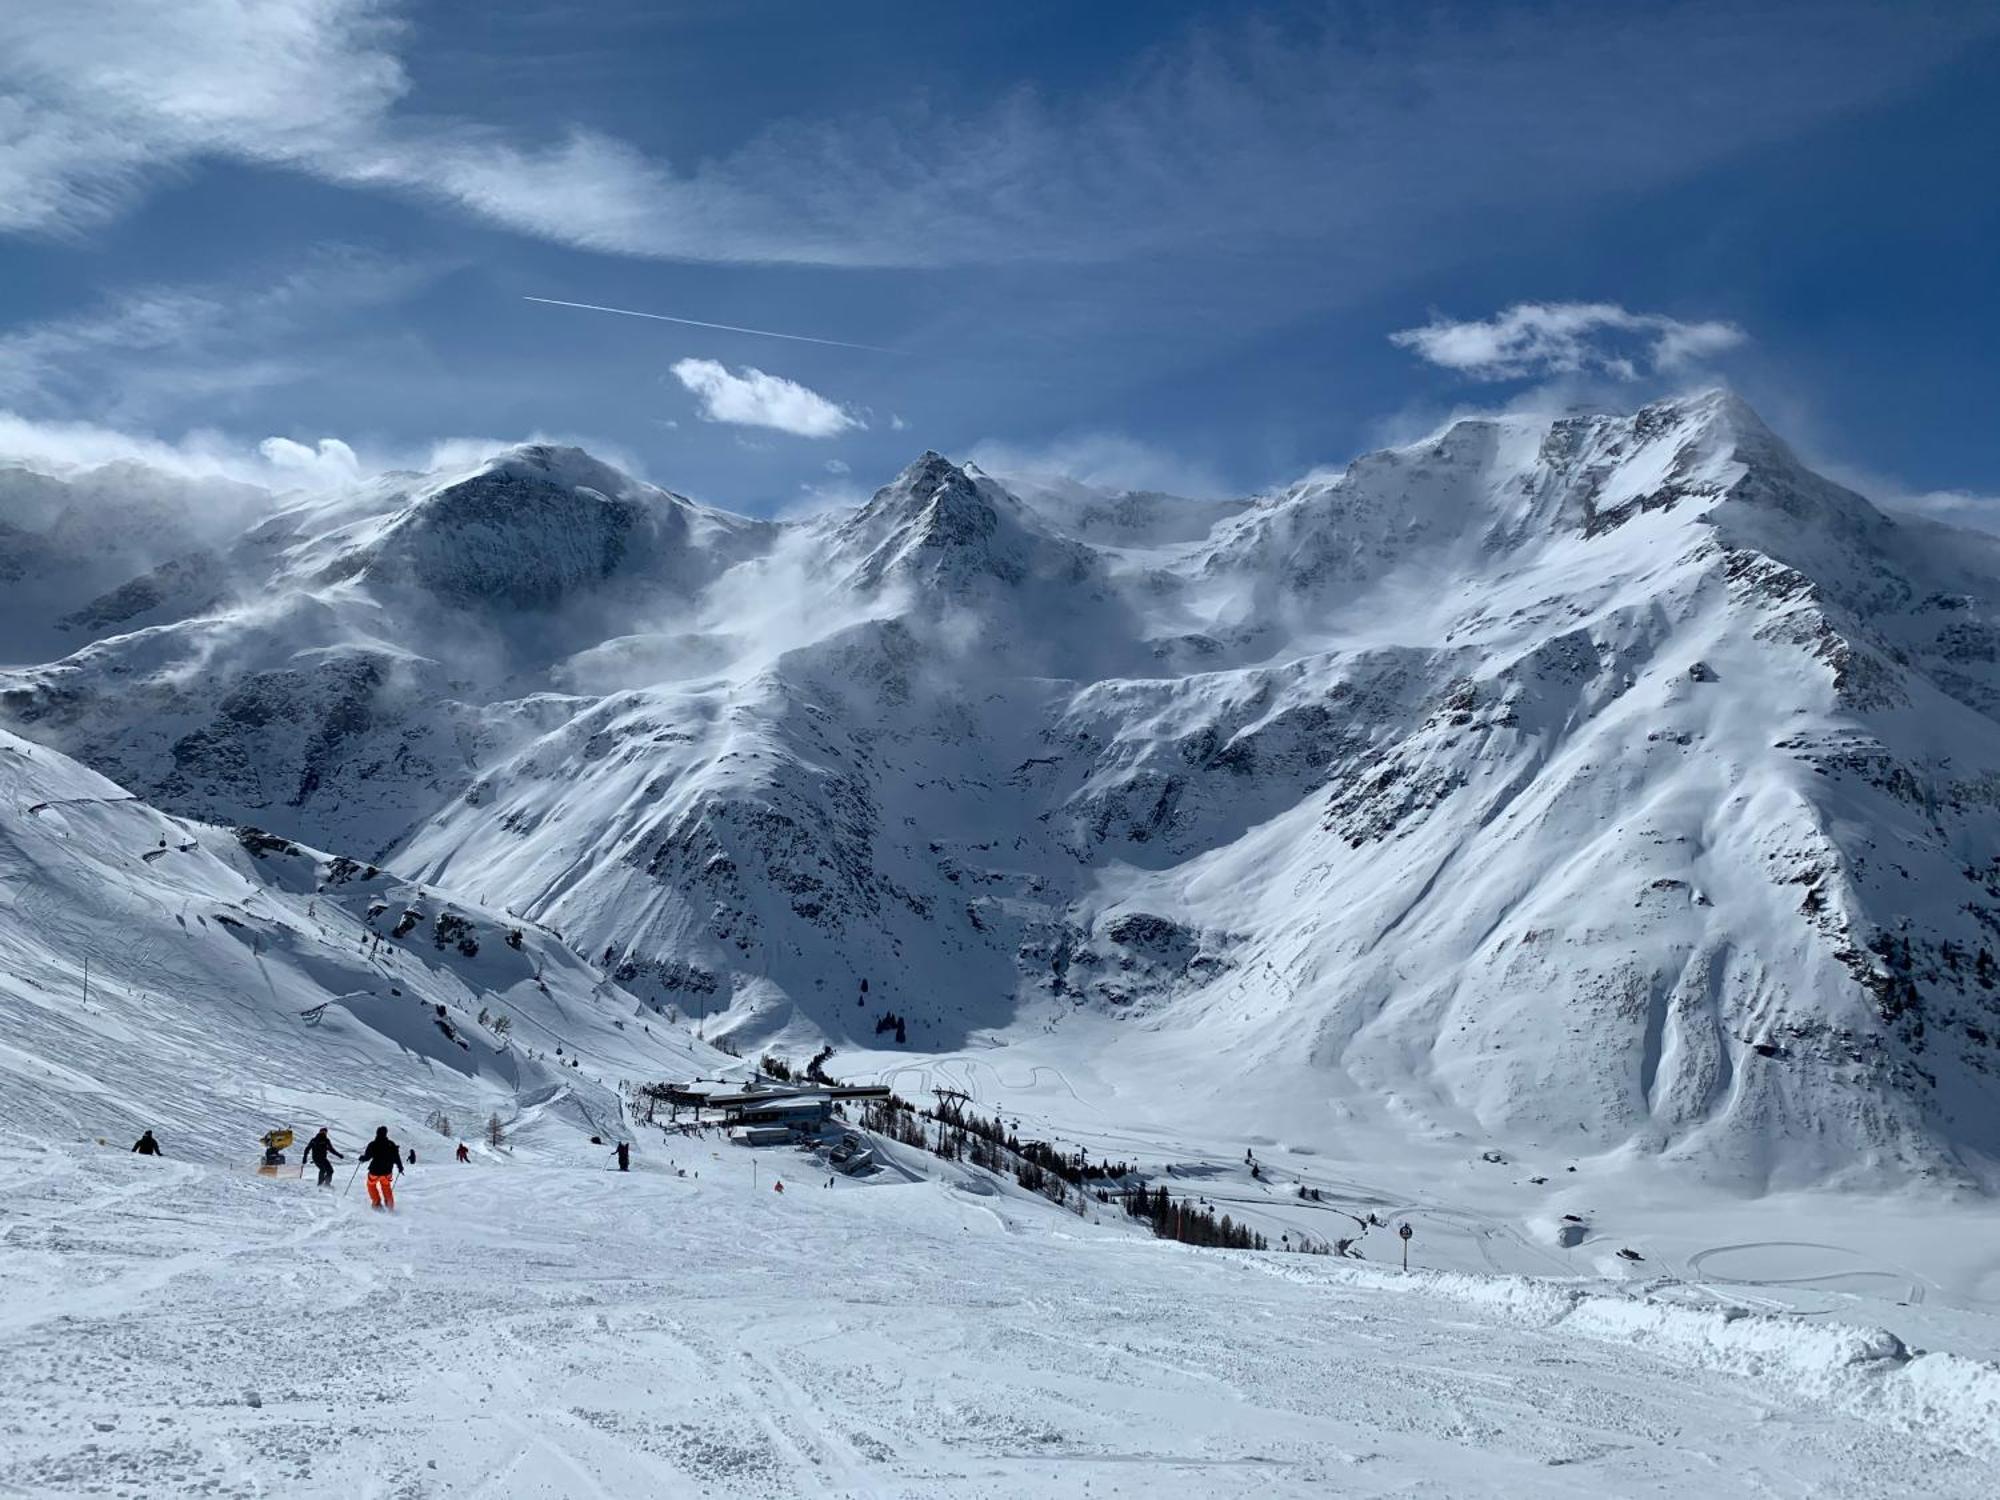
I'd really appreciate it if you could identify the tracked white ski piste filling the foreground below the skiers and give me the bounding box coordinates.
[0,1138,2000,1496]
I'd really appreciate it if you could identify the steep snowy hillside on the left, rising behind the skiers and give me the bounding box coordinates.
[0,734,730,1162]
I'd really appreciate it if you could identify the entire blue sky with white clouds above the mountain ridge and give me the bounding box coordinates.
[0,0,2000,518]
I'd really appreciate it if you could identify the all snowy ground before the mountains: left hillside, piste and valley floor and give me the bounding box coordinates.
[0,738,2000,1496]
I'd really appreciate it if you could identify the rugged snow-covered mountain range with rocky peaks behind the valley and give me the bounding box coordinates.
[0,392,2000,1184]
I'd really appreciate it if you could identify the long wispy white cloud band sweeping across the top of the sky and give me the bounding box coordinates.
[0,0,2000,266]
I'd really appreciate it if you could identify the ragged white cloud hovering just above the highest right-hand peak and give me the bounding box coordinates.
[1390,302,1746,380]
